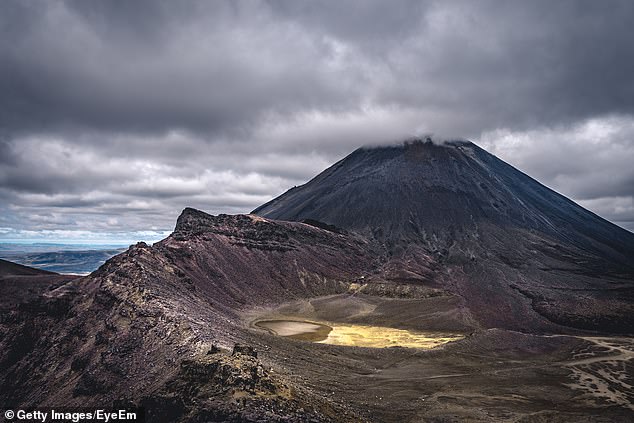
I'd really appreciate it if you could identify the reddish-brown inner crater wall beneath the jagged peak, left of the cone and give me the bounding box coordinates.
[160,208,380,314]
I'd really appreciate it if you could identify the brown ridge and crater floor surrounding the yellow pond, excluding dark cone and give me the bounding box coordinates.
[0,205,634,422]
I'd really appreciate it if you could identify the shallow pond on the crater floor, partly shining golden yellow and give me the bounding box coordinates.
[255,320,463,349]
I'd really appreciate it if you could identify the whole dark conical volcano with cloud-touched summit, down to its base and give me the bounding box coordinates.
[253,140,634,333]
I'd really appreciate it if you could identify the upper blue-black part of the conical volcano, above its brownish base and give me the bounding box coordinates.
[253,139,634,265]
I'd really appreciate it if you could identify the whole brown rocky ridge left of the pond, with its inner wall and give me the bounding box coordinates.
[0,215,377,422]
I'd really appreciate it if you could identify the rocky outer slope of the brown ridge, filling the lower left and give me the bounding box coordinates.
[0,237,356,422]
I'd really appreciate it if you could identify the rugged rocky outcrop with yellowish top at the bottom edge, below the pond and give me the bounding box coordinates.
[140,344,346,423]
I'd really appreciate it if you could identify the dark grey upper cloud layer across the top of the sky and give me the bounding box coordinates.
[0,1,634,135]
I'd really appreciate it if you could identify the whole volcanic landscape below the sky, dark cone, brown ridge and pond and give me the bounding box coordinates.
[0,140,634,423]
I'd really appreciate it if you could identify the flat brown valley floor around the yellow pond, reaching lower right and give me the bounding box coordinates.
[244,295,634,422]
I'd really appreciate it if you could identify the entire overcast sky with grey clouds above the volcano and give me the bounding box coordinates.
[0,0,634,241]
